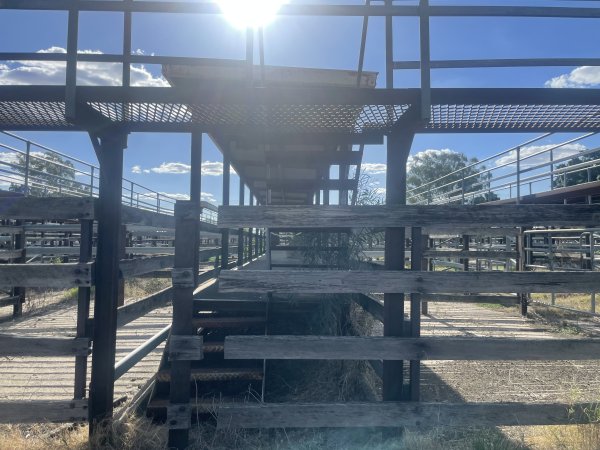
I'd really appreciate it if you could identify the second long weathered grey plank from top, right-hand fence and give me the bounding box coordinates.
[219,270,600,294]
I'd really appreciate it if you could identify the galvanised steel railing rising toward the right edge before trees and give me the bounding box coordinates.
[407,133,600,204]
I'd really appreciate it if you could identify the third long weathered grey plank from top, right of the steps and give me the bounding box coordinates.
[225,336,600,361]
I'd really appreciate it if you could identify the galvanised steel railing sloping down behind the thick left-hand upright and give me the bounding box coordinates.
[0,131,217,224]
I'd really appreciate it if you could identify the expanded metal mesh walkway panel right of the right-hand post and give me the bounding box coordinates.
[427,105,600,130]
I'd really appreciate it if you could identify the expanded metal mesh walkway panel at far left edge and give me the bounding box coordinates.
[0,101,71,129]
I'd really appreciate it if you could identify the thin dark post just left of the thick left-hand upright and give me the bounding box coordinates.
[73,220,94,399]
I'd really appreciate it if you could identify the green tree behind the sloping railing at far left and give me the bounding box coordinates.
[8,153,90,197]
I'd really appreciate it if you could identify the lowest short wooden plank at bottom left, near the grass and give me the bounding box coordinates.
[0,399,88,425]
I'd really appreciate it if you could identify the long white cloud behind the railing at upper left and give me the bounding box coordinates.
[0,47,169,87]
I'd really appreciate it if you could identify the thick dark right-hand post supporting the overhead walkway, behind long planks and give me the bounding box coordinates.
[383,132,414,401]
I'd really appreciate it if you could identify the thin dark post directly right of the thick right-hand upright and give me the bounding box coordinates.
[410,227,423,402]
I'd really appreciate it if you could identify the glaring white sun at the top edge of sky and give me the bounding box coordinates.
[217,0,285,28]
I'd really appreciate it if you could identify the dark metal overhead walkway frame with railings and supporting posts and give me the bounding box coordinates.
[0,0,600,448]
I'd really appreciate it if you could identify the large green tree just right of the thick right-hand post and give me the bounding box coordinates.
[406,150,498,204]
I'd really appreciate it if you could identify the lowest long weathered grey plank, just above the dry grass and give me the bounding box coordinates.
[217,402,592,429]
